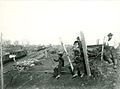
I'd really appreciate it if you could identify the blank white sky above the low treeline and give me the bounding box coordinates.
[0,0,120,45]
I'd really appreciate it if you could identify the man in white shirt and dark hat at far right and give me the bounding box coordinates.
[104,33,117,68]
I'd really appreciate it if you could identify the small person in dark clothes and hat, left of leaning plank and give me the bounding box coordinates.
[54,51,64,79]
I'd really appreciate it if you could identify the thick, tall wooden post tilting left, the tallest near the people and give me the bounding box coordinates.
[80,32,91,76]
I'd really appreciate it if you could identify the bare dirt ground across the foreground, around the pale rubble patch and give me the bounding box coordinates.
[0,48,120,89]
